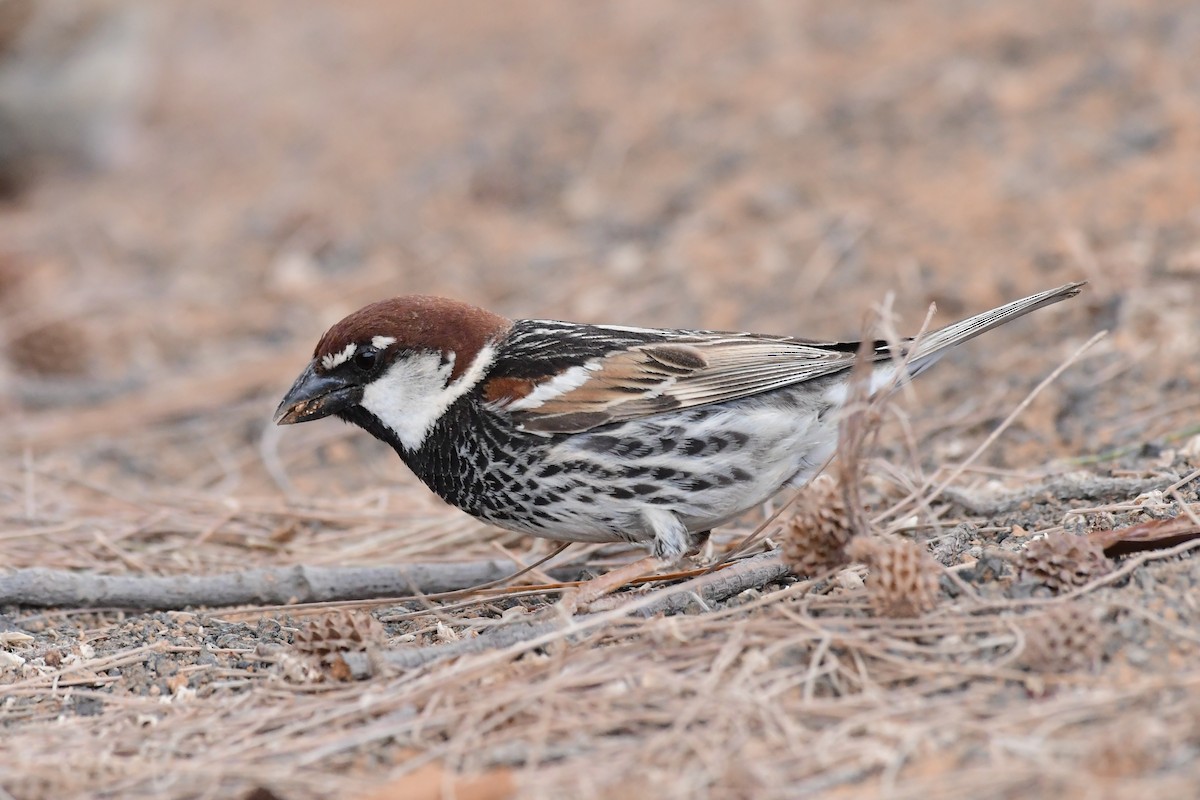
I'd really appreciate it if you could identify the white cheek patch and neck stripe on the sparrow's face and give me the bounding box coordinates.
[359,345,496,450]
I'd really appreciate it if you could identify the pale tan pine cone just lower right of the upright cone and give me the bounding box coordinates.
[846,536,941,616]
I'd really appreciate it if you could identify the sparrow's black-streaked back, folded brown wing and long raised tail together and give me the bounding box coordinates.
[482,283,1084,435]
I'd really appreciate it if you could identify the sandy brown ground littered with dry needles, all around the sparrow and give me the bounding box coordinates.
[0,0,1200,800]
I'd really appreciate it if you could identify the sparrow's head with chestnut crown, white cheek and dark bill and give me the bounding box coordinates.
[275,295,512,451]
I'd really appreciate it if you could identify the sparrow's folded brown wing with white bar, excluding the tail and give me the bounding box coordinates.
[485,326,888,434]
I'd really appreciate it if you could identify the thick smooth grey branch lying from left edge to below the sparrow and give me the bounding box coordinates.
[0,559,592,608]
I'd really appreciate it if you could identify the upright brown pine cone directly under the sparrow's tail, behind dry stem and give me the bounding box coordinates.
[780,475,853,576]
